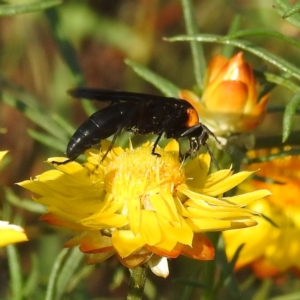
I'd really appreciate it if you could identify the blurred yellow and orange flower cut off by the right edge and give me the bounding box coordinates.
[224,151,300,278]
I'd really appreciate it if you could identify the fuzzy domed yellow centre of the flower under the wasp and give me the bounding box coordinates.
[104,144,185,200]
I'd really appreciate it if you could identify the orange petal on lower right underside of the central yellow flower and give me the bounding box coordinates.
[182,233,215,260]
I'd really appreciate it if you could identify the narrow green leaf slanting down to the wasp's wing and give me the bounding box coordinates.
[125,59,180,97]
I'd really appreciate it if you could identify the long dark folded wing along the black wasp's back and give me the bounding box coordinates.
[68,88,188,105]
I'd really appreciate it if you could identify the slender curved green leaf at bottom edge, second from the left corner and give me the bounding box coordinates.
[45,249,69,300]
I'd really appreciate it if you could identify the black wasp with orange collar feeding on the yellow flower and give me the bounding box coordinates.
[55,88,218,168]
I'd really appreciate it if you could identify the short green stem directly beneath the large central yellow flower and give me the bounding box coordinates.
[127,265,147,300]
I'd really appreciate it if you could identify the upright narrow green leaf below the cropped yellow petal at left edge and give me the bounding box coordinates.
[6,245,23,300]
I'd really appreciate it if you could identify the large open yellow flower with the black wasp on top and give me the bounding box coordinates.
[20,141,268,277]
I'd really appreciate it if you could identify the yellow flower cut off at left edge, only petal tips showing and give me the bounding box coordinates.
[0,151,28,247]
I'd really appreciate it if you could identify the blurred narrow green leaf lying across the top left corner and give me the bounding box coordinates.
[0,0,62,16]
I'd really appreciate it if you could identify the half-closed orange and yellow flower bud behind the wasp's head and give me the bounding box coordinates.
[179,52,269,134]
